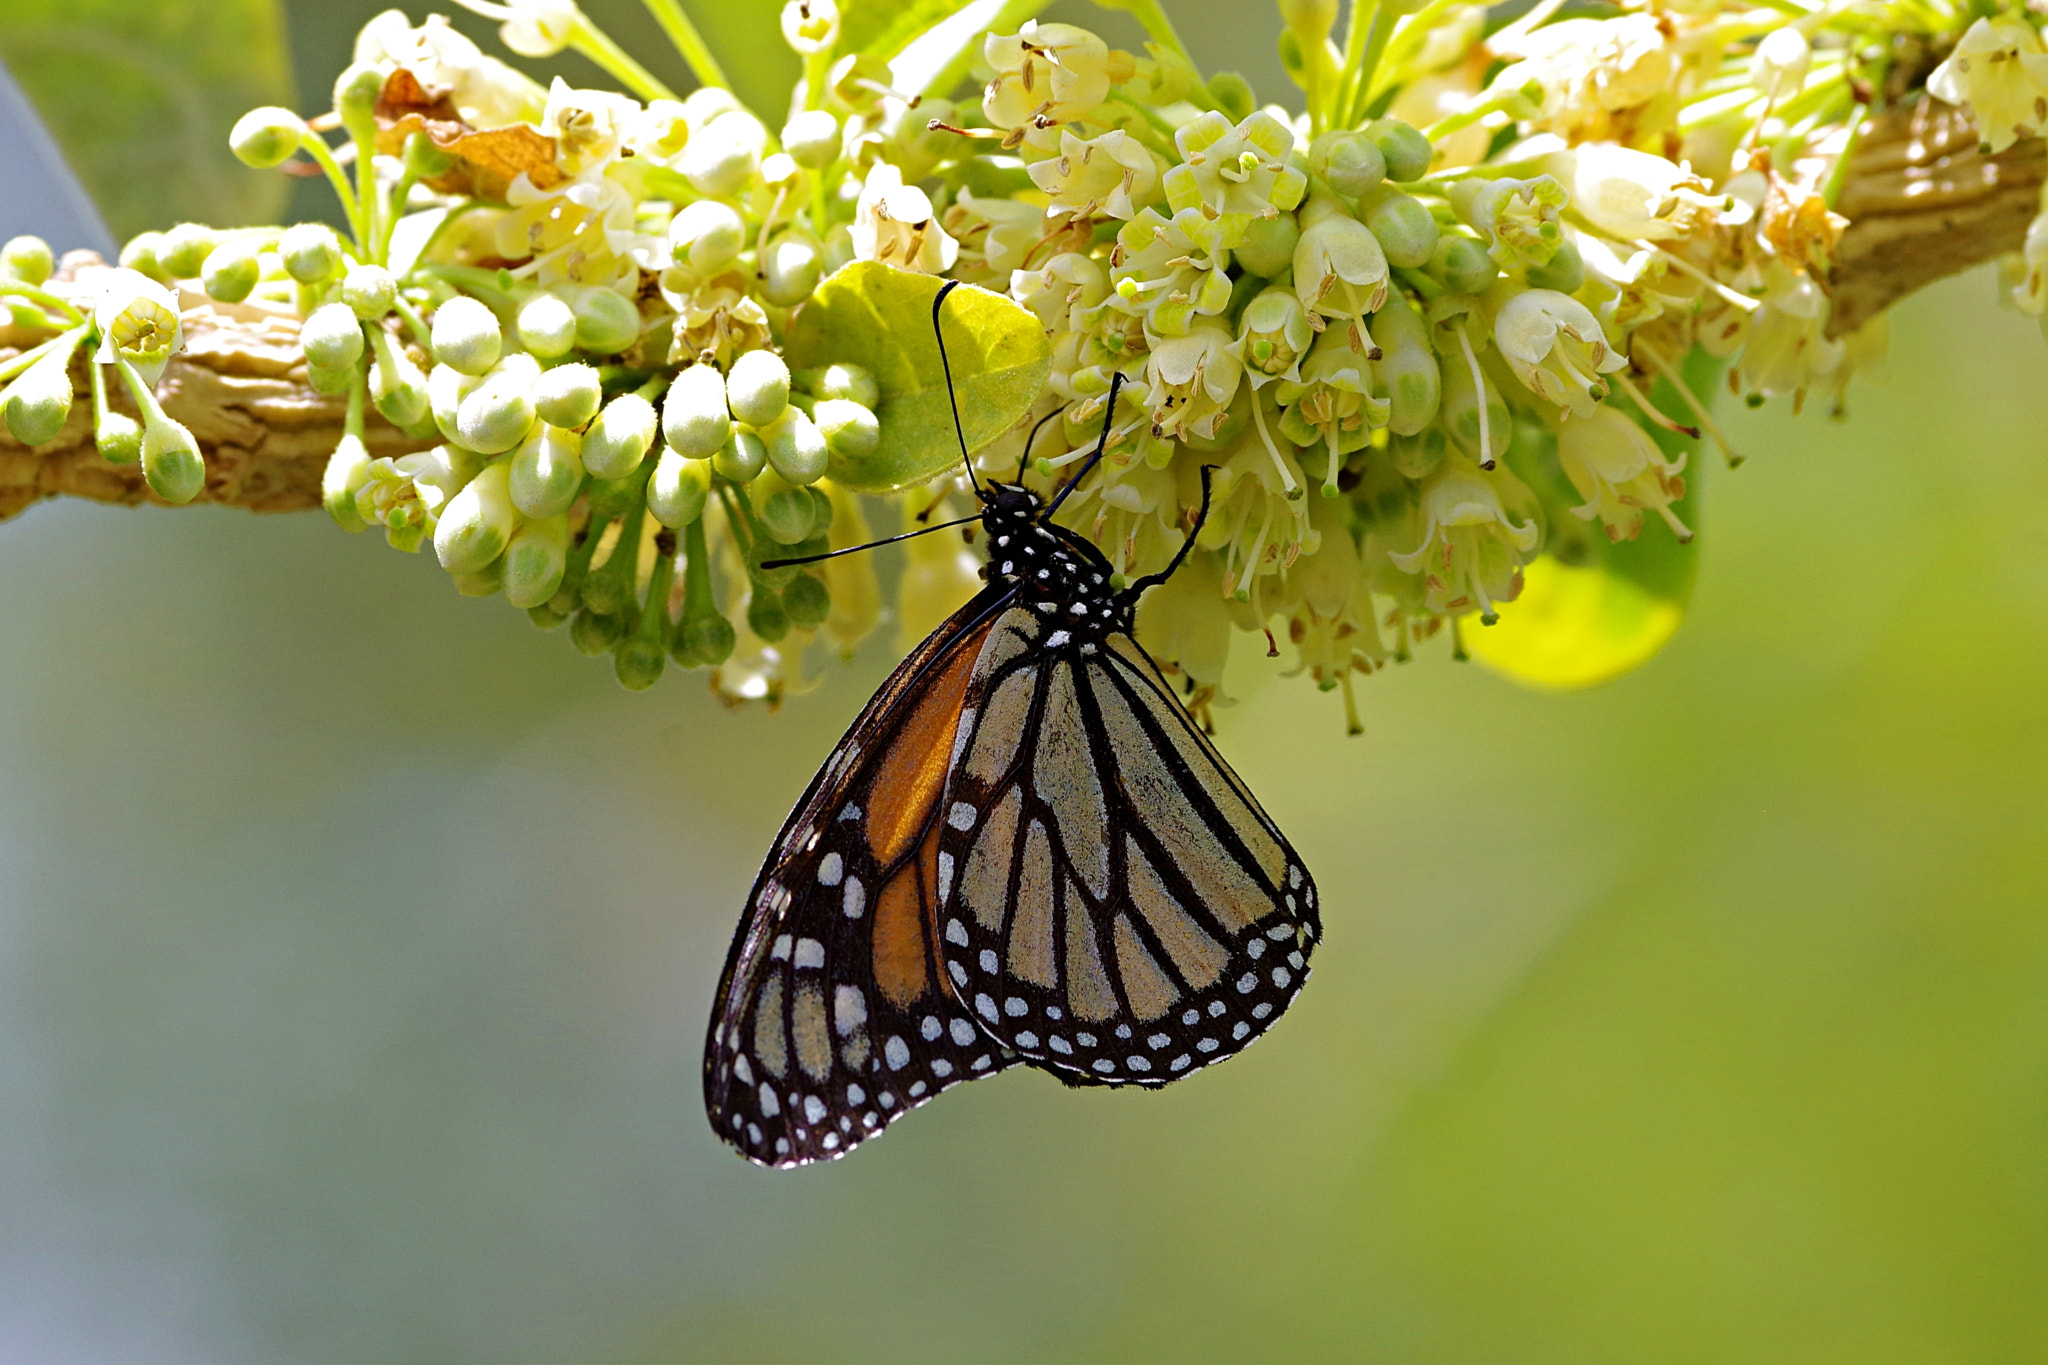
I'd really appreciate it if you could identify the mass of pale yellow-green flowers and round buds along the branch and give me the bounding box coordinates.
[0,0,2015,724]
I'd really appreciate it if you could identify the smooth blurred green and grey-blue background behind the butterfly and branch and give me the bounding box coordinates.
[0,0,2048,1365]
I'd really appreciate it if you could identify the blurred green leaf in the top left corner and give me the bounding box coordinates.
[0,0,295,239]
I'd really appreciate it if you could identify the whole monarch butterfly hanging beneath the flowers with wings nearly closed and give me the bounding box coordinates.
[705,282,1321,1166]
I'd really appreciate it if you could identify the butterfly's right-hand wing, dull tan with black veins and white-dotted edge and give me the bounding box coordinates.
[938,608,1321,1087]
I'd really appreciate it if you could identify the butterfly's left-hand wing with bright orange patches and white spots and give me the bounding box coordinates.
[705,591,1016,1166]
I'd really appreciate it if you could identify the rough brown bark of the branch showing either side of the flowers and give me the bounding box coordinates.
[0,98,2048,518]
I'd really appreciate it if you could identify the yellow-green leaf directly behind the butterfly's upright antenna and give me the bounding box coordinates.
[782,260,1053,493]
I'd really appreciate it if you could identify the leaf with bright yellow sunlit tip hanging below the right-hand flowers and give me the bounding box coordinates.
[1460,350,1724,690]
